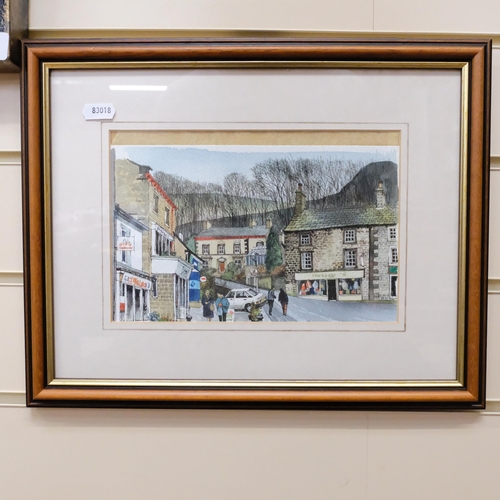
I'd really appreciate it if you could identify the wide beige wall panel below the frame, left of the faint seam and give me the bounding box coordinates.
[0,408,367,500]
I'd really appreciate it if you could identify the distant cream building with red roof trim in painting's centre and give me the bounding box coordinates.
[194,219,272,273]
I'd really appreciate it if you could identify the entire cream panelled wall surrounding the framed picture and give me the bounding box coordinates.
[0,0,500,500]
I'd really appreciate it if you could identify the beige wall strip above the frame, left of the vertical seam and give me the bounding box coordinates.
[30,0,373,31]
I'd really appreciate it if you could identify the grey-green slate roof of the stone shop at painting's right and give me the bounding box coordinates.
[285,205,398,233]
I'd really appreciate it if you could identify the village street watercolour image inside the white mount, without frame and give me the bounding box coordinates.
[111,145,400,326]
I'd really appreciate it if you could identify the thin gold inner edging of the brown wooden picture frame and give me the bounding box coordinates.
[42,57,469,387]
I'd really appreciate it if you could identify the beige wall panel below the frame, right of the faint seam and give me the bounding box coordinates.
[366,413,500,500]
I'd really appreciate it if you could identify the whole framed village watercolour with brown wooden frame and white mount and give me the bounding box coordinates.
[23,38,491,409]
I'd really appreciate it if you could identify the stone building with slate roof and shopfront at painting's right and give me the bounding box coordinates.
[284,183,398,301]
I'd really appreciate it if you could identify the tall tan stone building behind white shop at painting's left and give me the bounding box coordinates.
[115,159,193,321]
